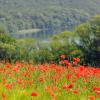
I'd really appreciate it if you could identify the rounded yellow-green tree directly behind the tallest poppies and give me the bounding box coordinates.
[50,31,83,61]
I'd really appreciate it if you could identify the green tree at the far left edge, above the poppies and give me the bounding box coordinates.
[0,25,16,61]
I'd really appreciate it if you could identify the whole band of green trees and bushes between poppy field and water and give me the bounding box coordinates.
[0,15,100,67]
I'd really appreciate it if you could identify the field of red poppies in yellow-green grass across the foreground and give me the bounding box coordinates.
[0,55,100,100]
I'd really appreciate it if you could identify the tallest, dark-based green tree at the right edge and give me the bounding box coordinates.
[76,15,100,66]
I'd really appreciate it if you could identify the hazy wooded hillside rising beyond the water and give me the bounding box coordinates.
[0,0,100,37]
